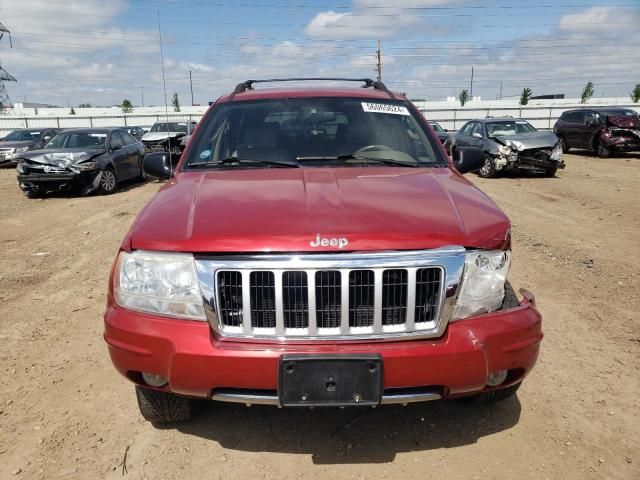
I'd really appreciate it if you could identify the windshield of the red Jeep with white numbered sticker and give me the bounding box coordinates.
[185,98,447,168]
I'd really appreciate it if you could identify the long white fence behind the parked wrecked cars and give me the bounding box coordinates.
[0,104,639,136]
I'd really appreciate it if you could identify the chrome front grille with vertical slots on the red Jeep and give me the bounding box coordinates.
[196,247,464,341]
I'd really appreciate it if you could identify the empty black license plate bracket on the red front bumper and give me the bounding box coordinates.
[278,354,383,407]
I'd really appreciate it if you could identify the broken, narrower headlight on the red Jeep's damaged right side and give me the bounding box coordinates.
[453,250,511,320]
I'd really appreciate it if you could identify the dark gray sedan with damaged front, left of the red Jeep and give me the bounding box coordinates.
[16,128,144,197]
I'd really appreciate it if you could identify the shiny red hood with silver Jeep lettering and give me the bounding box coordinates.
[125,167,510,253]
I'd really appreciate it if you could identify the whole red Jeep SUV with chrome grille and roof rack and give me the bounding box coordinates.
[104,79,542,422]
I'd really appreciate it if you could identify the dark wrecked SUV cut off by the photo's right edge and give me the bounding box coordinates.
[553,107,640,158]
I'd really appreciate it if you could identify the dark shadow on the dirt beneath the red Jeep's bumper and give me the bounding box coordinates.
[169,396,521,464]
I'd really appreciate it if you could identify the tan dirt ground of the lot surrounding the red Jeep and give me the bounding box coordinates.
[0,155,640,480]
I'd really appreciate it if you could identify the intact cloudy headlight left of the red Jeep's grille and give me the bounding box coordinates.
[114,251,206,321]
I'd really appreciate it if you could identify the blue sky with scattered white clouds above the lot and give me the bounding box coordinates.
[0,0,640,106]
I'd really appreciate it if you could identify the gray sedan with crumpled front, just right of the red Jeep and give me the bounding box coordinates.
[451,118,564,178]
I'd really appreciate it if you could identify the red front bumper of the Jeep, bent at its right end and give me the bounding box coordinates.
[104,293,542,404]
